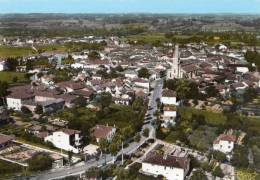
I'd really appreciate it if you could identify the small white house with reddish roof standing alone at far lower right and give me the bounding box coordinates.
[213,134,236,154]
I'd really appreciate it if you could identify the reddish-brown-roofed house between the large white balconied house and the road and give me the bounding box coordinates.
[92,125,116,143]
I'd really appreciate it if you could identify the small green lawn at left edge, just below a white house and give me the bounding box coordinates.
[0,71,28,84]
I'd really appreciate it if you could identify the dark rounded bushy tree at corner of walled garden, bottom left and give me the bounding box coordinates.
[28,153,53,171]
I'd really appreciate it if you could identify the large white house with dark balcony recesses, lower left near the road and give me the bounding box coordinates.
[44,129,82,153]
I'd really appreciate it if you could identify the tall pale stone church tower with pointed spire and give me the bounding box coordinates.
[167,45,181,79]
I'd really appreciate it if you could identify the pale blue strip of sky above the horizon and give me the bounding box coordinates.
[0,0,260,14]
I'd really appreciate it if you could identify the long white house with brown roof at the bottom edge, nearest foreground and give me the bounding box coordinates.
[142,152,190,180]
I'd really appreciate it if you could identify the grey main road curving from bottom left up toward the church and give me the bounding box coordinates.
[31,79,163,180]
